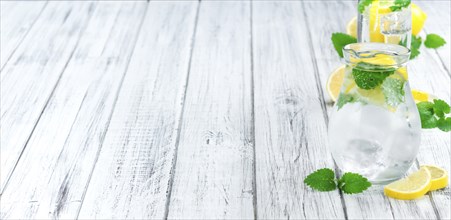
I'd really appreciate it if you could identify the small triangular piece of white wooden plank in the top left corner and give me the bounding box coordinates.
[0,1,47,69]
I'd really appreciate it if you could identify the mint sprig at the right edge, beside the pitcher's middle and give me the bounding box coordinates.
[417,99,451,132]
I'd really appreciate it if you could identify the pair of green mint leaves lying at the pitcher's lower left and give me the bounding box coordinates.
[304,168,371,194]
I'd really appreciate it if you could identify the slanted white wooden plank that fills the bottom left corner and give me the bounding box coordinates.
[0,2,147,219]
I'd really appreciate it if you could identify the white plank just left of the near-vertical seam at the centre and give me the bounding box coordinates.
[169,1,254,219]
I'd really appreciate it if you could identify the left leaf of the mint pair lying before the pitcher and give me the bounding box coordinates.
[304,168,337,192]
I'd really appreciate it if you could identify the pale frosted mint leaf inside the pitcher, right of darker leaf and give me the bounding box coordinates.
[381,78,404,106]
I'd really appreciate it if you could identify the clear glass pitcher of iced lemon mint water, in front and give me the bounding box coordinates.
[328,43,421,184]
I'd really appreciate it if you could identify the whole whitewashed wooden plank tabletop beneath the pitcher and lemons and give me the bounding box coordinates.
[0,1,451,219]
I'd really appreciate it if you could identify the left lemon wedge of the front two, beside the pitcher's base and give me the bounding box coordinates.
[384,167,432,200]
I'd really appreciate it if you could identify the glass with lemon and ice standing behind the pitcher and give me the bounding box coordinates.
[357,0,412,49]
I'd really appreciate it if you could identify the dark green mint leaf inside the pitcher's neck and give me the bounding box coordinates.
[352,62,395,90]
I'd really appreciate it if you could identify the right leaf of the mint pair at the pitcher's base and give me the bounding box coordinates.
[338,173,371,194]
